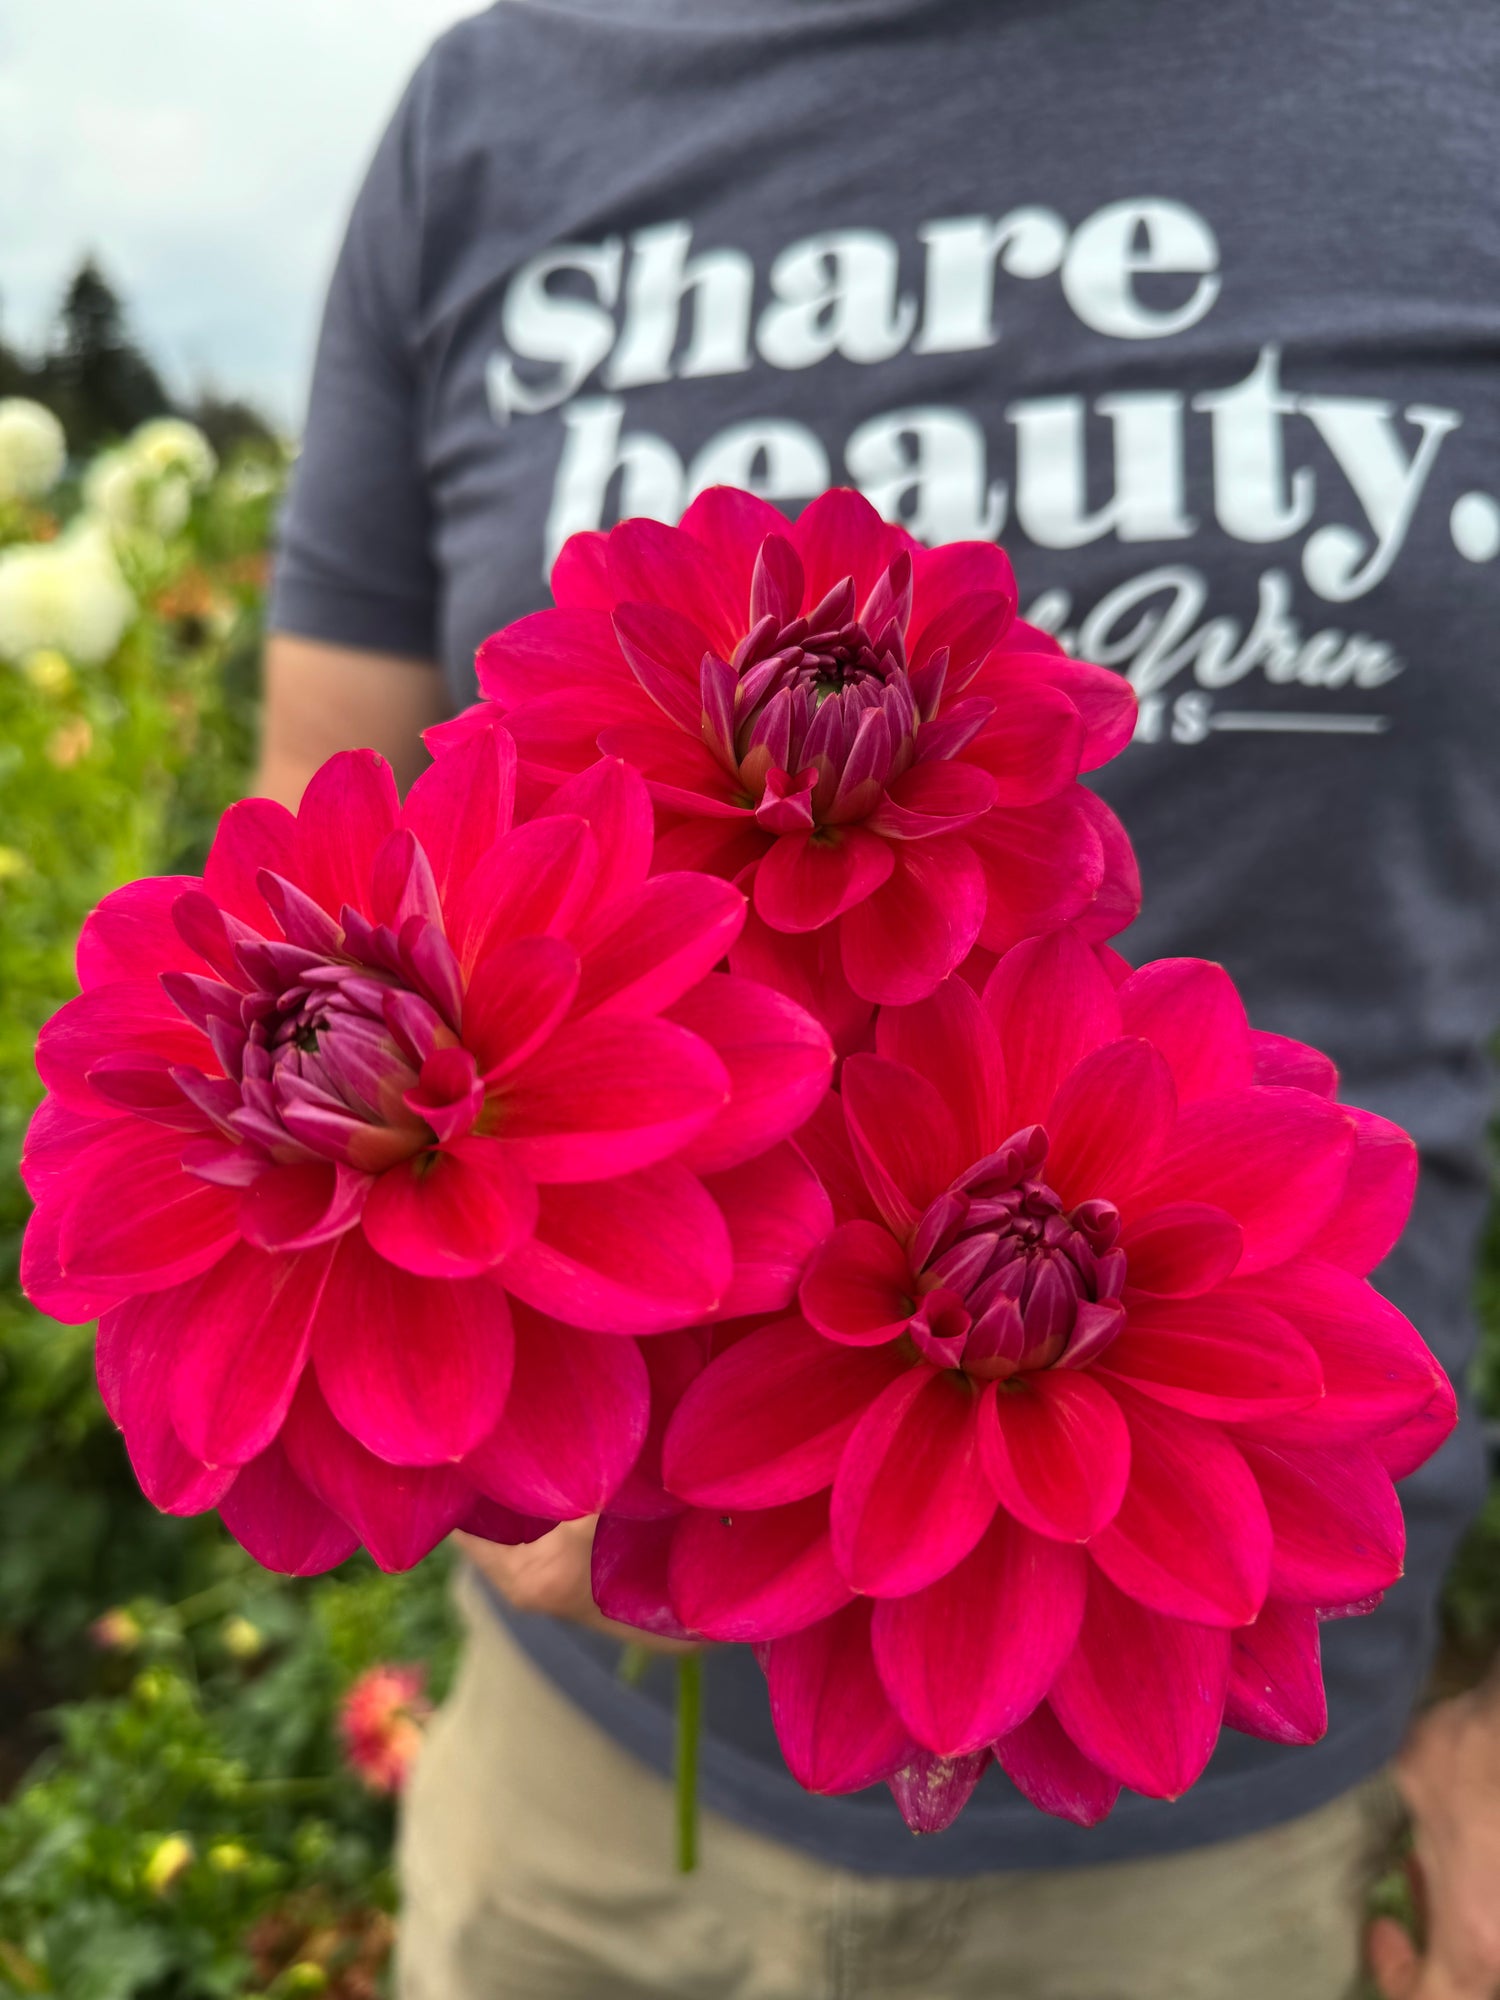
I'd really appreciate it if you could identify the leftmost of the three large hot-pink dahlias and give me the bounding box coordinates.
[22,730,832,1572]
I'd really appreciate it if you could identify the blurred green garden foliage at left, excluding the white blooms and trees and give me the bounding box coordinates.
[0,418,454,2000]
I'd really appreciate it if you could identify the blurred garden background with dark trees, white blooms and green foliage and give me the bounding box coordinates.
[0,4,1500,2000]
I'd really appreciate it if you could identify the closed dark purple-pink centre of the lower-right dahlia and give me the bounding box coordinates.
[910,1126,1126,1380]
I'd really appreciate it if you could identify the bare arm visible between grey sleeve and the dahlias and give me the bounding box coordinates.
[254,632,448,808]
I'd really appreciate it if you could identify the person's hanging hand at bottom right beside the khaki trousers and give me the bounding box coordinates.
[1368,1670,1500,2000]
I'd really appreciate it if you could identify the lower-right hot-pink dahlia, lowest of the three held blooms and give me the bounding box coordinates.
[596,930,1454,1828]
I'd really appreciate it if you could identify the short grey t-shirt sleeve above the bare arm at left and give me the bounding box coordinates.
[270,64,438,660]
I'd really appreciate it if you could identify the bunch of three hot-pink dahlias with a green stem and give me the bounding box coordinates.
[24,488,1454,1854]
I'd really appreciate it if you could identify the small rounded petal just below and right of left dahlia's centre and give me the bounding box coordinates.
[360,1134,536,1278]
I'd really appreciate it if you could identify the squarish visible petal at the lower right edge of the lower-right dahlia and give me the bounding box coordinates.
[1242,1442,1406,1604]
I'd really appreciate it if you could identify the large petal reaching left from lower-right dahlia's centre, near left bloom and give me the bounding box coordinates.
[662,1318,910,1508]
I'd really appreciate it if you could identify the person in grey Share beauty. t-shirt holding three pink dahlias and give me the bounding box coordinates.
[41,0,1500,2000]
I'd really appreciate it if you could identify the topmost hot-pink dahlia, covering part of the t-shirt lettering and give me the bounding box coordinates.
[478,486,1140,1026]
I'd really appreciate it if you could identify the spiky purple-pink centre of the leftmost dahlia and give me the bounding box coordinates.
[162,850,484,1184]
